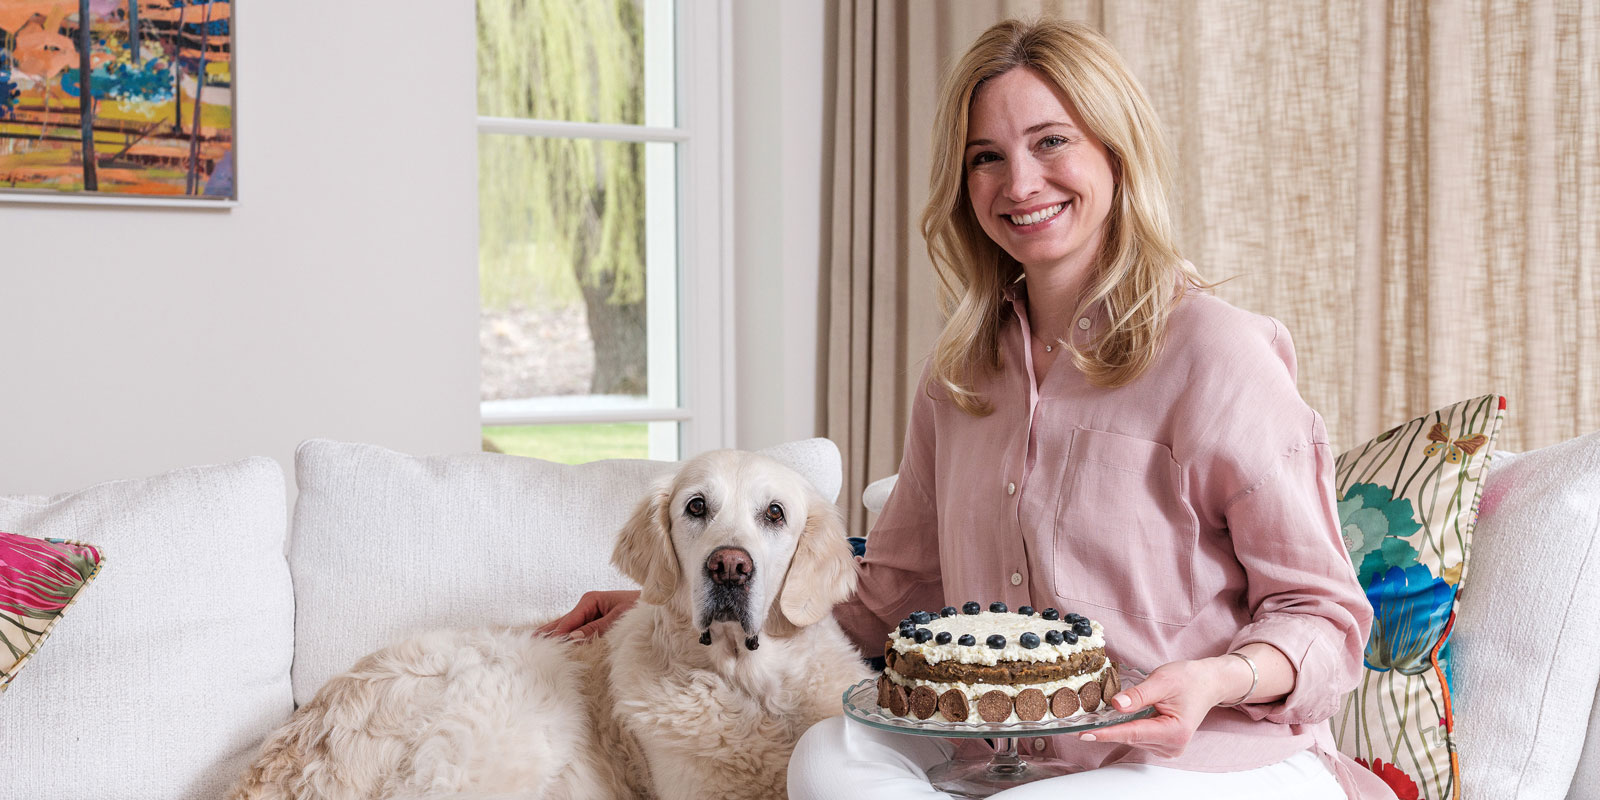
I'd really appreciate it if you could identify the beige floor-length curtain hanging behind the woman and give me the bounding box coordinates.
[822,0,1600,531]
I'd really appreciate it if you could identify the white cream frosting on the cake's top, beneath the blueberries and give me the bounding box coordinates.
[890,611,1106,667]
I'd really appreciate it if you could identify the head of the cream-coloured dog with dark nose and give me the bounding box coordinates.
[611,450,856,648]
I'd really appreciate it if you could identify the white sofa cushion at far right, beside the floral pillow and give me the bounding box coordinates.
[1454,434,1600,800]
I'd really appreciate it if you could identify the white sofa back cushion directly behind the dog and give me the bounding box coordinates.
[290,438,840,704]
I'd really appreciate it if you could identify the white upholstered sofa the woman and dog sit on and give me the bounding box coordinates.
[0,434,1600,800]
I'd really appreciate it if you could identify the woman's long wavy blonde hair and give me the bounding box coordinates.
[922,18,1210,416]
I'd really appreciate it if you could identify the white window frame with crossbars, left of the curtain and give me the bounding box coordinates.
[477,0,738,456]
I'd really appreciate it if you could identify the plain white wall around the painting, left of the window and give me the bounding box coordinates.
[0,0,478,494]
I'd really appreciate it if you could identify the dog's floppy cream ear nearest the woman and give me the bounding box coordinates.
[778,491,856,627]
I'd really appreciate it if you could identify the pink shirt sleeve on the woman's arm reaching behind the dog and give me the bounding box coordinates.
[834,371,944,654]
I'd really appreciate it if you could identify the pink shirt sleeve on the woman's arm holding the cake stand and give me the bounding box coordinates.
[1184,315,1373,725]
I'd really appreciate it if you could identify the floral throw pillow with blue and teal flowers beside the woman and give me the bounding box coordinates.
[1333,395,1506,800]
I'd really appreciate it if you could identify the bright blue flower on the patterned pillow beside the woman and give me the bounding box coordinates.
[1365,563,1456,675]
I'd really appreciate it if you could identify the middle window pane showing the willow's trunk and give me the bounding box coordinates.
[478,134,678,400]
